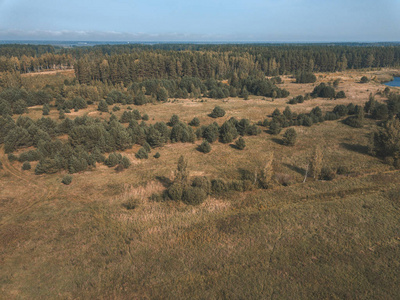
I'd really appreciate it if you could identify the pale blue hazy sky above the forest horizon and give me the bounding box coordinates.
[0,0,400,42]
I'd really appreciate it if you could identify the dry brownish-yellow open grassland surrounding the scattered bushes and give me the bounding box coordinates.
[0,71,400,299]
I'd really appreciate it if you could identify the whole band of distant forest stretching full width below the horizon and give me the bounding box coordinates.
[0,44,400,86]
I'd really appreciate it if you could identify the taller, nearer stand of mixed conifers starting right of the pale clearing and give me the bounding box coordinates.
[74,45,400,85]
